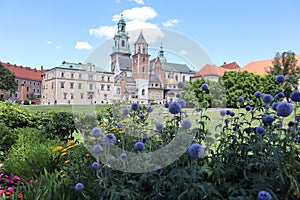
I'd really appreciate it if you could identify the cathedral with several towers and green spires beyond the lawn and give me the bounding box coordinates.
[110,16,195,104]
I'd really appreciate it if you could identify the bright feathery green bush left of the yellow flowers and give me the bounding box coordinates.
[3,128,61,178]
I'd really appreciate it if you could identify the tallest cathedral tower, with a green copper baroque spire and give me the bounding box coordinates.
[110,14,131,75]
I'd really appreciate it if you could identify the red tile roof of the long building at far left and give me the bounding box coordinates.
[1,62,46,82]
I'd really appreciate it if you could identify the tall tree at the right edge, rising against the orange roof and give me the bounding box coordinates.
[270,51,300,101]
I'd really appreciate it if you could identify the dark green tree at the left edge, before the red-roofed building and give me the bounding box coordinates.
[0,63,18,93]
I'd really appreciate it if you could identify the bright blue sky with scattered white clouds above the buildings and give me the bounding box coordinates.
[0,0,300,69]
